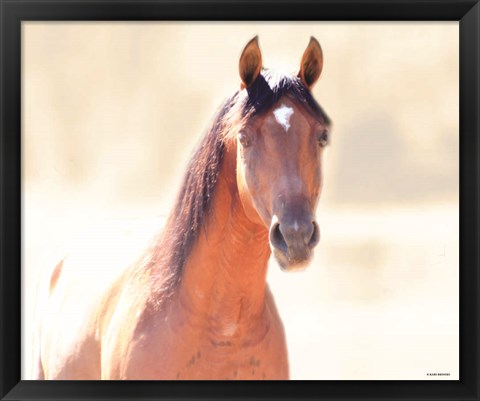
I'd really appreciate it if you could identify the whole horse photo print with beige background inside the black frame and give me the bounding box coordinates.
[22,21,460,380]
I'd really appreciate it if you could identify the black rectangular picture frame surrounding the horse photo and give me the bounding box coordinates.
[0,0,480,400]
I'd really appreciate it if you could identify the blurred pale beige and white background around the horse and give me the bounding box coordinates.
[22,22,459,380]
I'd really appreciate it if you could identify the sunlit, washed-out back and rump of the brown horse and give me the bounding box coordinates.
[33,216,165,380]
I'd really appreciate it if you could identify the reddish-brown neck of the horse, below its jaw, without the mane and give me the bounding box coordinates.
[174,148,270,338]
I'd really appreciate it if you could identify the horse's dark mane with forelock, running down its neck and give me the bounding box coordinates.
[148,70,330,291]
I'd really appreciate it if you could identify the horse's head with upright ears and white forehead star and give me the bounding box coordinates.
[232,37,329,270]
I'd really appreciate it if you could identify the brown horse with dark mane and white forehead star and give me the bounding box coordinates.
[34,37,330,380]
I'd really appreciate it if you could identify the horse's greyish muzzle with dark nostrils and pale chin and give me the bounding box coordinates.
[269,216,320,271]
